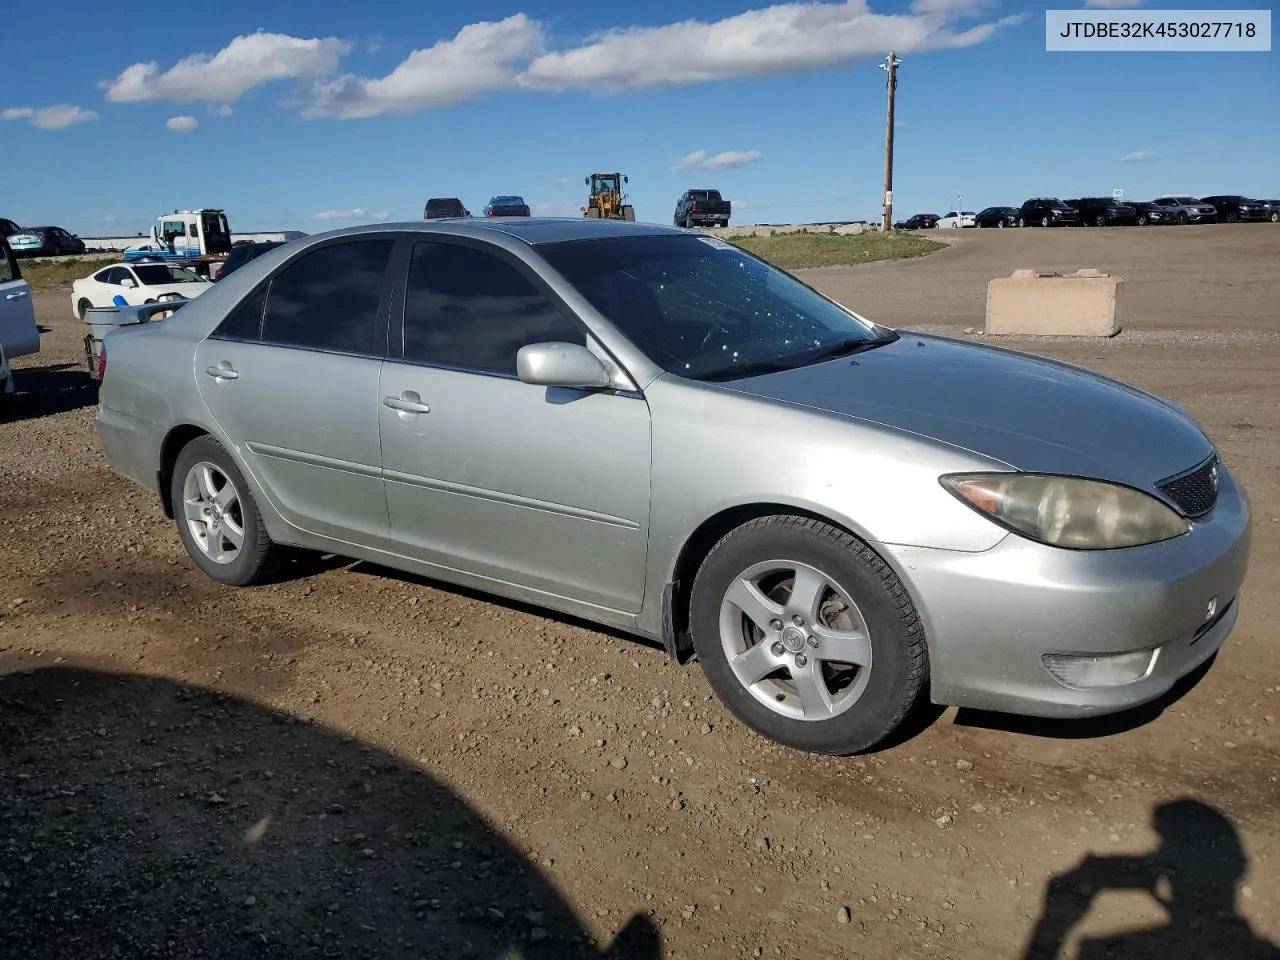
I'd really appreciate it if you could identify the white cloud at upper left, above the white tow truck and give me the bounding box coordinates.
[101,31,351,104]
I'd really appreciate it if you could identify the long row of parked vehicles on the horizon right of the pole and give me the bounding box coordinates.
[893,193,1280,230]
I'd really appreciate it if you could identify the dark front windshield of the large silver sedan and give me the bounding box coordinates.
[538,237,897,380]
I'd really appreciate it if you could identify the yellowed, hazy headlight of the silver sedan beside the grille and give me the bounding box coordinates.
[940,474,1190,550]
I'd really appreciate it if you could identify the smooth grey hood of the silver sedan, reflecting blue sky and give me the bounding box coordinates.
[722,334,1213,488]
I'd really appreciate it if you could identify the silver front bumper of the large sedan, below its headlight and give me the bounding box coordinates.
[883,467,1252,717]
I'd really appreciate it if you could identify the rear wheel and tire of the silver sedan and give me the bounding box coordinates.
[170,436,280,586]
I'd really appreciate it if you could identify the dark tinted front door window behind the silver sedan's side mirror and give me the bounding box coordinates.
[404,241,586,375]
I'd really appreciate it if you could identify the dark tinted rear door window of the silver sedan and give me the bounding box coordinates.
[262,239,396,355]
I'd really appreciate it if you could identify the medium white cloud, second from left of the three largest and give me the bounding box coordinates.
[302,13,547,120]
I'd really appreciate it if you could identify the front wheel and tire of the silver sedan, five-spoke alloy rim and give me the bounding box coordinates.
[690,516,928,755]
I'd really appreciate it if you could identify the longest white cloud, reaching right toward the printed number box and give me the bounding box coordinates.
[520,0,1025,93]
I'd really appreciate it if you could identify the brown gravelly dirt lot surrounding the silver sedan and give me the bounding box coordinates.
[0,224,1280,960]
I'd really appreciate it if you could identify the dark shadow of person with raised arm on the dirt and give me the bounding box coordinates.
[1023,799,1280,960]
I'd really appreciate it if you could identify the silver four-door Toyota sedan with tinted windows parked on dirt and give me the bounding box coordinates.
[97,218,1251,754]
